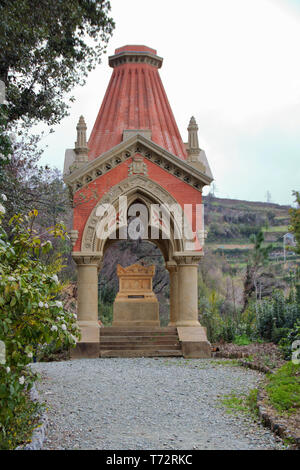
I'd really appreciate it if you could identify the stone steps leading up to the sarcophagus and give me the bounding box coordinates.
[100,326,182,357]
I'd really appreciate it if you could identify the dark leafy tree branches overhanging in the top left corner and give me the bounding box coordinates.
[0,0,114,124]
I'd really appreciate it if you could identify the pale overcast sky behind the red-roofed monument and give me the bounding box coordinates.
[37,0,300,204]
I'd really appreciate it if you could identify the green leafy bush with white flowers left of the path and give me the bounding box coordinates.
[0,210,79,449]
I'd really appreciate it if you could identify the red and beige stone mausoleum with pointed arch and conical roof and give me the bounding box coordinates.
[64,45,213,357]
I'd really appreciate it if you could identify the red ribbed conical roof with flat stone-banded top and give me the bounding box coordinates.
[88,46,187,160]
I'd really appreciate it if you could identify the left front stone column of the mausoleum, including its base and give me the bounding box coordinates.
[72,253,101,357]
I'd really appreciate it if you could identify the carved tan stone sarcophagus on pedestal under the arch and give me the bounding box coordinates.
[113,264,159,326]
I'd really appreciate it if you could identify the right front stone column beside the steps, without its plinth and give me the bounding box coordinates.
[174,255,200,326]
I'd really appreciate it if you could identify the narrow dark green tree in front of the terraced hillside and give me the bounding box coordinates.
[243,230,273,311]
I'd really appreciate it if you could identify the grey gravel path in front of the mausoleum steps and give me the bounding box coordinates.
[33,358,283,450]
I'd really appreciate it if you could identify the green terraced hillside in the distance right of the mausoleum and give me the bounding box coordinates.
[204,196,300,271]
